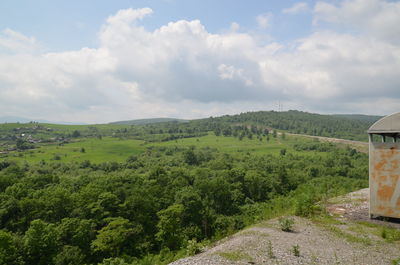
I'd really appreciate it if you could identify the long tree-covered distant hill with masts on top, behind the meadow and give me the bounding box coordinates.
[106,110,380,141]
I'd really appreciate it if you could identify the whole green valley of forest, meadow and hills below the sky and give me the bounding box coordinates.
[0,112,376,265]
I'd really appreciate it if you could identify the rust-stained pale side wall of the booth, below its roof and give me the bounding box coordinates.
[369,142,400,218]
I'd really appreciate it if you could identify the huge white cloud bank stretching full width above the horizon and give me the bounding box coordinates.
[0,3,400,122]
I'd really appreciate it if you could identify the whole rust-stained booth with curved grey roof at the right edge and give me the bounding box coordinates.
[368,113,400,218]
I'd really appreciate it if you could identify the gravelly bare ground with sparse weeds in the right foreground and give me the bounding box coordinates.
[171,187,400,265]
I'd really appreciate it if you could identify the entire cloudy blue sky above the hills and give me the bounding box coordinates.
[0,0,400,123]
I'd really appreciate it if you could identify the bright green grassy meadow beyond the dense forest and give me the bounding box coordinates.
[0,133,322,163]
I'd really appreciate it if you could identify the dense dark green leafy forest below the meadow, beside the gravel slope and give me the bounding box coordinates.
[0,140,367,264]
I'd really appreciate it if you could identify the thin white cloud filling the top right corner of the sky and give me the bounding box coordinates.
[314,0,400,44]
